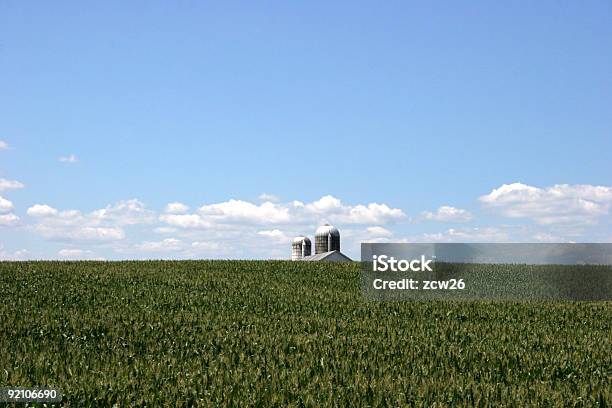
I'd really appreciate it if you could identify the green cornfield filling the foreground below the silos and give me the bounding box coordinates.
[0,261,612,407]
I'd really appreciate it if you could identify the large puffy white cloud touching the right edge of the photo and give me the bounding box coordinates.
[480,183,612,225]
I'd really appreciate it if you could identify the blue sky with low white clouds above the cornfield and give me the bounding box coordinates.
[0,1,612,259]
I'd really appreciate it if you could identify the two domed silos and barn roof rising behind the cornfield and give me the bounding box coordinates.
[291,224,351,262]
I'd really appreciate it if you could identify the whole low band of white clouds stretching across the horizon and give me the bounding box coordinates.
[0,183,612,259]
